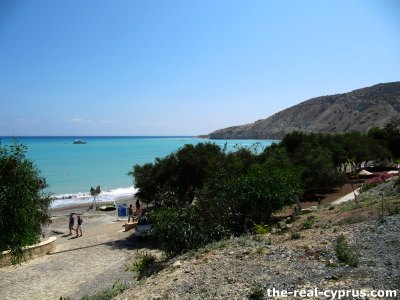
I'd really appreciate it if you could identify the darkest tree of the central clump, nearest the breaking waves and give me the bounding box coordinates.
[128,143,225,207]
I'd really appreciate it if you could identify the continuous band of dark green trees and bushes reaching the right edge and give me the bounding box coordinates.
[130,125,400,255]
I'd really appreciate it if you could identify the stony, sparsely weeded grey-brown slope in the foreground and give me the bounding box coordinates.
[115,182,400,300]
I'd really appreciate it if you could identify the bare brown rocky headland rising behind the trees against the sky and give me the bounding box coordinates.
[208,82,400,139]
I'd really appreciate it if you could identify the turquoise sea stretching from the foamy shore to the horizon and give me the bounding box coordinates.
[1,137,275,207]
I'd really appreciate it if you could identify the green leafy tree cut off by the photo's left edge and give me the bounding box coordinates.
[0,142,51,263]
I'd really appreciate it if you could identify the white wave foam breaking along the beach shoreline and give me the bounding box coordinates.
[51,187,138,208]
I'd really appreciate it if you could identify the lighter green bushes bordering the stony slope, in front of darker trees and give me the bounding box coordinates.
[153,168,296,255]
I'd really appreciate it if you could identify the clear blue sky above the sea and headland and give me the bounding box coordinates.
[0,0,400,136]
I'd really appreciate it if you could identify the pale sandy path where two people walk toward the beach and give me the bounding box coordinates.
[0,205,153,300]
